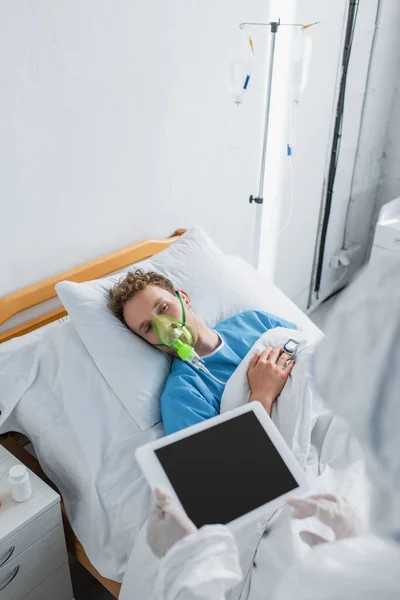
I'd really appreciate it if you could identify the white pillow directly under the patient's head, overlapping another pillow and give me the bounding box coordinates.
[56,274,171,430]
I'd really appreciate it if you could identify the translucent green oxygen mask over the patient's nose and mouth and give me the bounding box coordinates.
[151,315,196,361]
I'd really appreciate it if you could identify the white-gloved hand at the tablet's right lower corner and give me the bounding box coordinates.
[287,494,363,546]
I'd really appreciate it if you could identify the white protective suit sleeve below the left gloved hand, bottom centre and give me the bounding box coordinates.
[157,525,242,600]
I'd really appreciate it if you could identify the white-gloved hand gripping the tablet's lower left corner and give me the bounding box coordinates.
[147,488,197,558]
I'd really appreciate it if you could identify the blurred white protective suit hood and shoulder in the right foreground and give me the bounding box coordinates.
[274,257,400,600]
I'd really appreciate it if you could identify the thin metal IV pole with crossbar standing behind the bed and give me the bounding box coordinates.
[239,19,316,268]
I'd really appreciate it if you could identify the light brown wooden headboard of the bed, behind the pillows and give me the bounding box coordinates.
[0,229,186,343]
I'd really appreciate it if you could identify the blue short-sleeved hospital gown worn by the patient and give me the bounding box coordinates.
[161,310,296,435]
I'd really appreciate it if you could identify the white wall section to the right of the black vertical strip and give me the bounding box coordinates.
[321,0,400,294]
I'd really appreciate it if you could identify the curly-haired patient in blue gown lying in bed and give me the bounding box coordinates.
[109,270,295,435]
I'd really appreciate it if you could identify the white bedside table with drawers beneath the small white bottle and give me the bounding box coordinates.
[0,445,73,600]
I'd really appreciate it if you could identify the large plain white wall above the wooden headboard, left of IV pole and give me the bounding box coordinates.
[0,0,268,295]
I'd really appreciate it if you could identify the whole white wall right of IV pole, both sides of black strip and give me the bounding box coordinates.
[262,0,400,309]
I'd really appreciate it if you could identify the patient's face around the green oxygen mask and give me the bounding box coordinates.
[124,285,197,354]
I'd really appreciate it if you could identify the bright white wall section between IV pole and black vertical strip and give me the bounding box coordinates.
[260,0,347,308]
